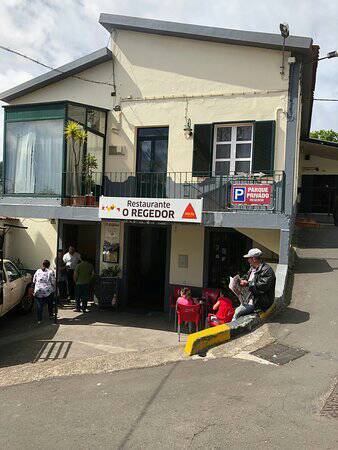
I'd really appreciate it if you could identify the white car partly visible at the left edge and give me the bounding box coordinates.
[0,259,34,317]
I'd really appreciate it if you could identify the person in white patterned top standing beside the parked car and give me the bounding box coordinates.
[33,259,56,324]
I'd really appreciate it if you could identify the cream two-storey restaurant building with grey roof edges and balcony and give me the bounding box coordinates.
[0,14,318,309]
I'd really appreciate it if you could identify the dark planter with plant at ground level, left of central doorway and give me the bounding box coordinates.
[97,264,121,309]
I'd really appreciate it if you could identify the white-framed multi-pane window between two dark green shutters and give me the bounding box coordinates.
[212,123,253,175]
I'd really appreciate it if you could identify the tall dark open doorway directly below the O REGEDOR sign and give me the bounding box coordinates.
[127,225,167,311]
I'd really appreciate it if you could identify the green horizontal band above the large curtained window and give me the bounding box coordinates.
[5,103,66,122]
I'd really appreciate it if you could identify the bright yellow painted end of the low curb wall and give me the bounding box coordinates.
[184,324,230,356]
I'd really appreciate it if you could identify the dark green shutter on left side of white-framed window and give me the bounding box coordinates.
[192,123,214,177]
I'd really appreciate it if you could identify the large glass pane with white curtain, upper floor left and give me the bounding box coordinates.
[5,119,64,195]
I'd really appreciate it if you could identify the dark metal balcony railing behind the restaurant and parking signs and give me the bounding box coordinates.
[63,171,285,213]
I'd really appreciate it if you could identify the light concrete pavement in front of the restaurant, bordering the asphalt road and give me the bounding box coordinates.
[0,298,271,386]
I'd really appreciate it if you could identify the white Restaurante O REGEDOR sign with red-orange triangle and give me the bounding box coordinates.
[99,196,203,223]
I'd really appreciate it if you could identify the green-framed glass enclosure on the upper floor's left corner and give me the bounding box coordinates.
[4,102,106,196]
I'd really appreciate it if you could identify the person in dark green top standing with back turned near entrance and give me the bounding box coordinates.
[74,255,94,313]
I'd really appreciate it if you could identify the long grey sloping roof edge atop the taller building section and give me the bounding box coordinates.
[99,13,312,53]
